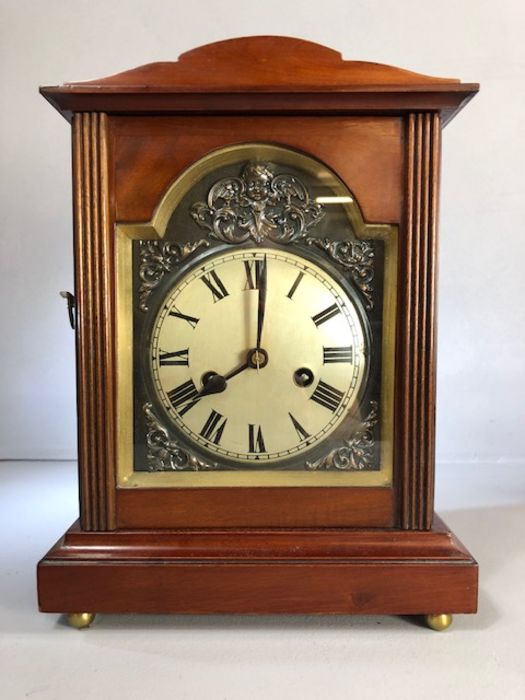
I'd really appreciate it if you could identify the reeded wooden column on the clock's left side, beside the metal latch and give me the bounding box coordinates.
[73,114,115,530]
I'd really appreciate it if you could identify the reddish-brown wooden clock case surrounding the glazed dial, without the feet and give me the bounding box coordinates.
[38,37,478,614]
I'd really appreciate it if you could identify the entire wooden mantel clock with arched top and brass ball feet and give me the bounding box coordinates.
[38,37,478,628]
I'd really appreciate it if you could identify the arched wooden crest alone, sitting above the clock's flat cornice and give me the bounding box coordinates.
[58,36,459,92]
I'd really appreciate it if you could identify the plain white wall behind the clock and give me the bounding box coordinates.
[0,0,525,464]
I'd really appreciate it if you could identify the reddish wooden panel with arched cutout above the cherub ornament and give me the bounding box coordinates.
[109,116,398,223]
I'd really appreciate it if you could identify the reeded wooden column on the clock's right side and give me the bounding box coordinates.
[395,114,441,529]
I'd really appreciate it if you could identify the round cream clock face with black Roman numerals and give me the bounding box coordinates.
[148,248,367,463]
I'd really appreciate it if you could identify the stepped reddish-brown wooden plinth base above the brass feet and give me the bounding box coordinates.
[38,517,478,616]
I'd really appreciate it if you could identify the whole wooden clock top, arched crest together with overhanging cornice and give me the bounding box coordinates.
[40,36,478,120]
